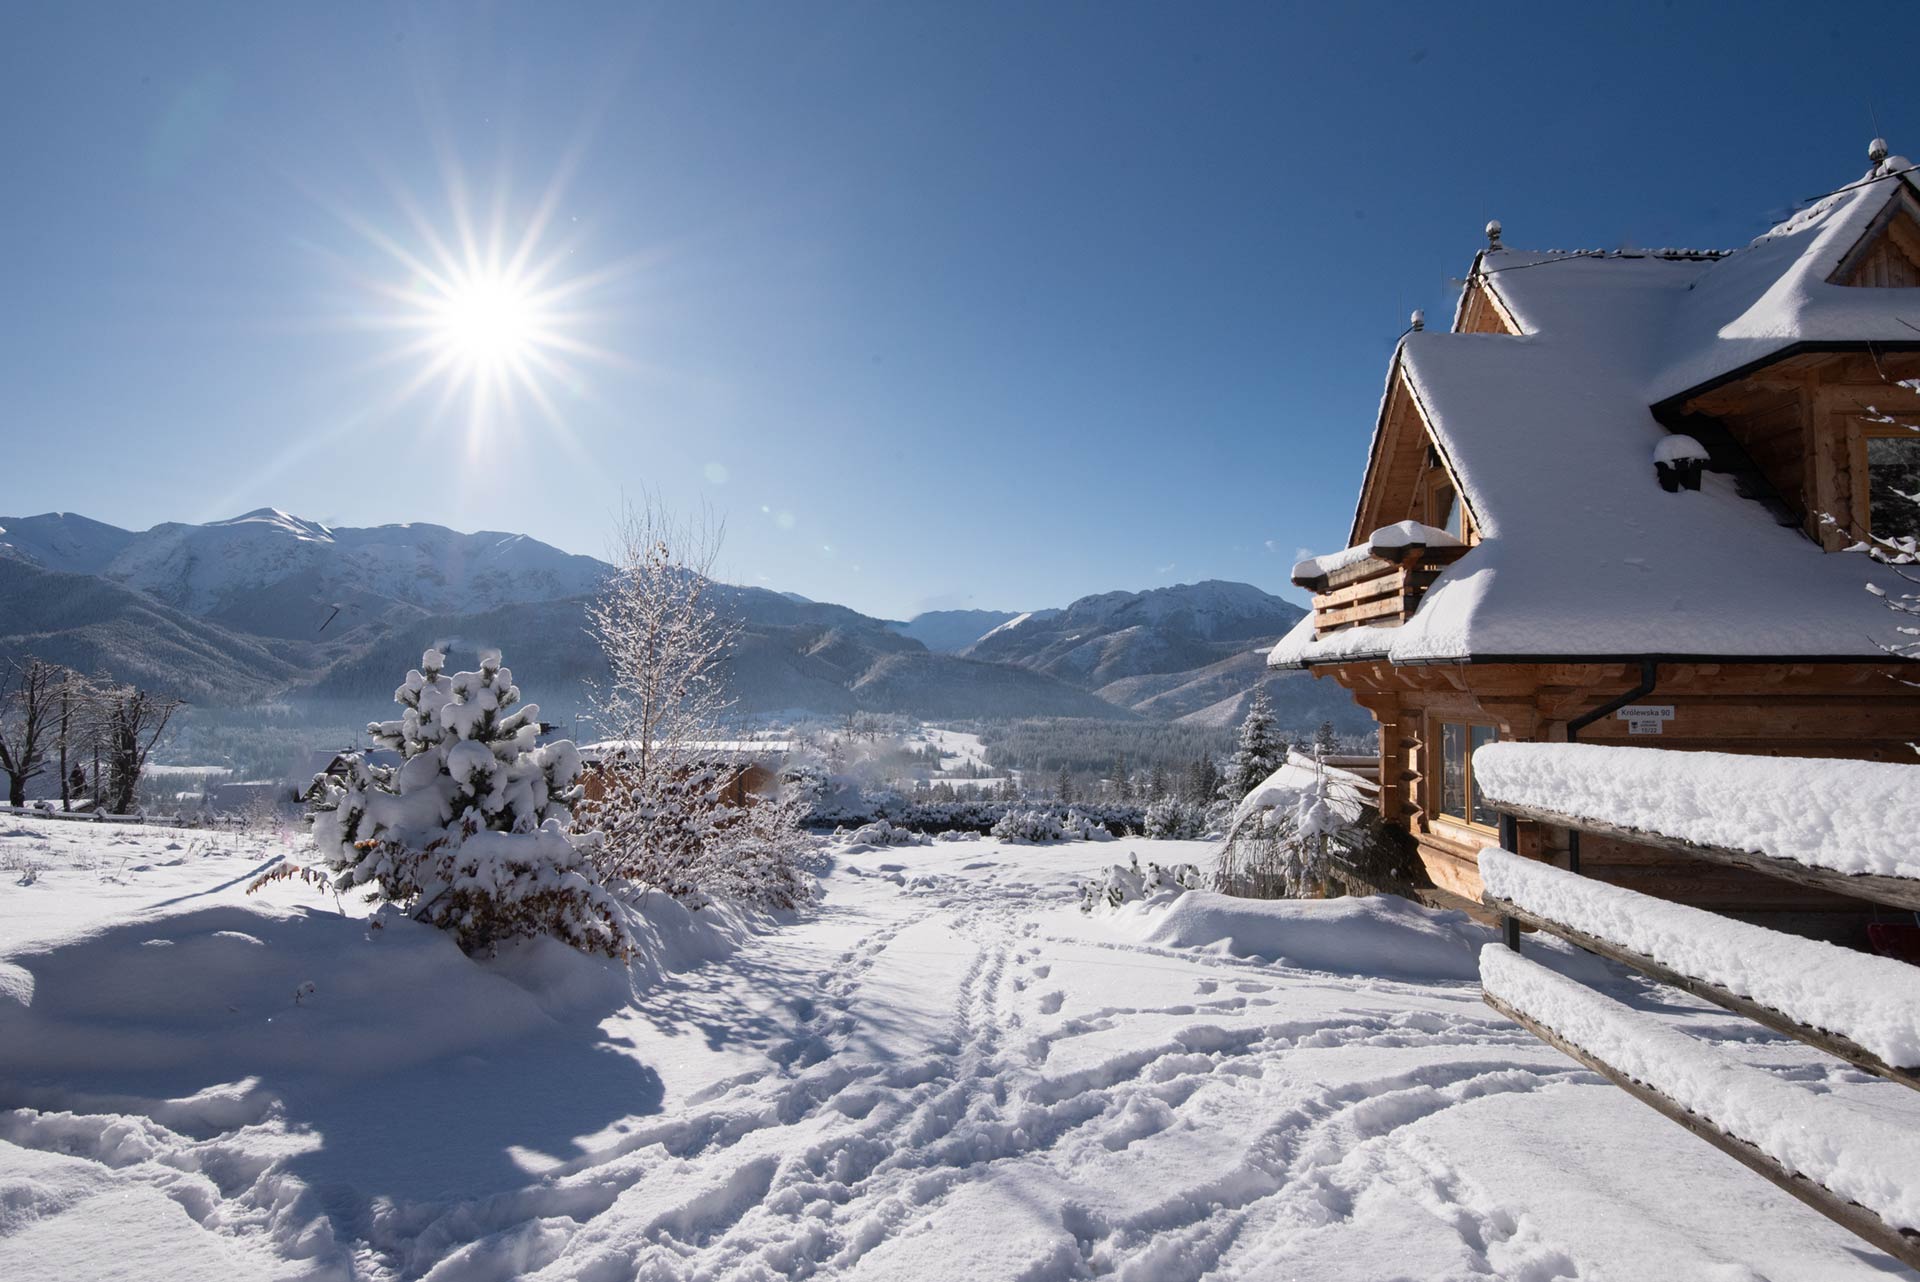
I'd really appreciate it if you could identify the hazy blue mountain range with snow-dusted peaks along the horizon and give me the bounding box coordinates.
[0,509,1363,729]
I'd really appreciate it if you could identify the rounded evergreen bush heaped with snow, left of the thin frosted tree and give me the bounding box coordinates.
[253,651,632,956]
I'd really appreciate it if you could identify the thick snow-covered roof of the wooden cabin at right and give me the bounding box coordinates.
[1269,159,1920,666]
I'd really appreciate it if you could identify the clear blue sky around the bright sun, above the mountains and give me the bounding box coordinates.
[0,4,1920,616]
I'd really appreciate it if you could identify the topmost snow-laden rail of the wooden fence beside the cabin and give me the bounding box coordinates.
[1473,743,1920,910]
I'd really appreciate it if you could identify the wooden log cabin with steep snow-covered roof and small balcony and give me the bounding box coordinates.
[1269,140,1920,938]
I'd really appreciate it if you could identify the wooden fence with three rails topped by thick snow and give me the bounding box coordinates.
[1473,745,1920,1269]
